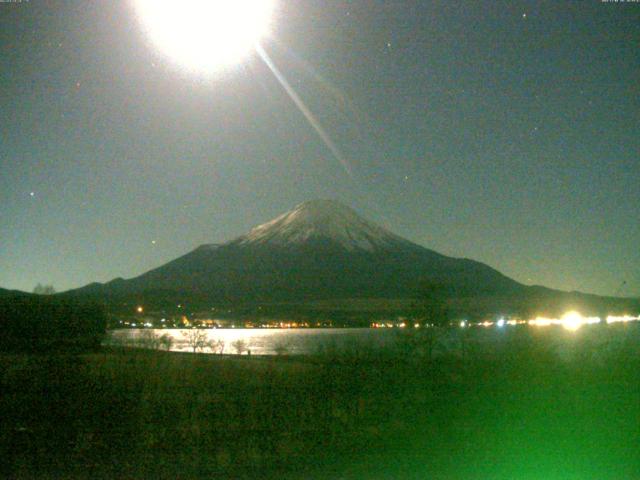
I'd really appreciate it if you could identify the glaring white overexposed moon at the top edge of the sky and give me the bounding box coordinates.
[134,0,274,73]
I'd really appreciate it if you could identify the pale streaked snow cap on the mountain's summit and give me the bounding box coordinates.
[237,200,406,251]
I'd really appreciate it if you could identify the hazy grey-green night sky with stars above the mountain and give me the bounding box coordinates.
[0,0,640,296]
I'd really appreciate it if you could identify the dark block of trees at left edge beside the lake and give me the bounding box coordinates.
[0,295,107,352]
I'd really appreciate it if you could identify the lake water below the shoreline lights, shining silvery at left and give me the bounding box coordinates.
[105,323,640,358]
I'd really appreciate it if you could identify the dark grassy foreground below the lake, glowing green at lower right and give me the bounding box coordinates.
[0,326,640,480]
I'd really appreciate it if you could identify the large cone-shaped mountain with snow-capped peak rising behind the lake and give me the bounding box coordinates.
[66,200,636,318]
